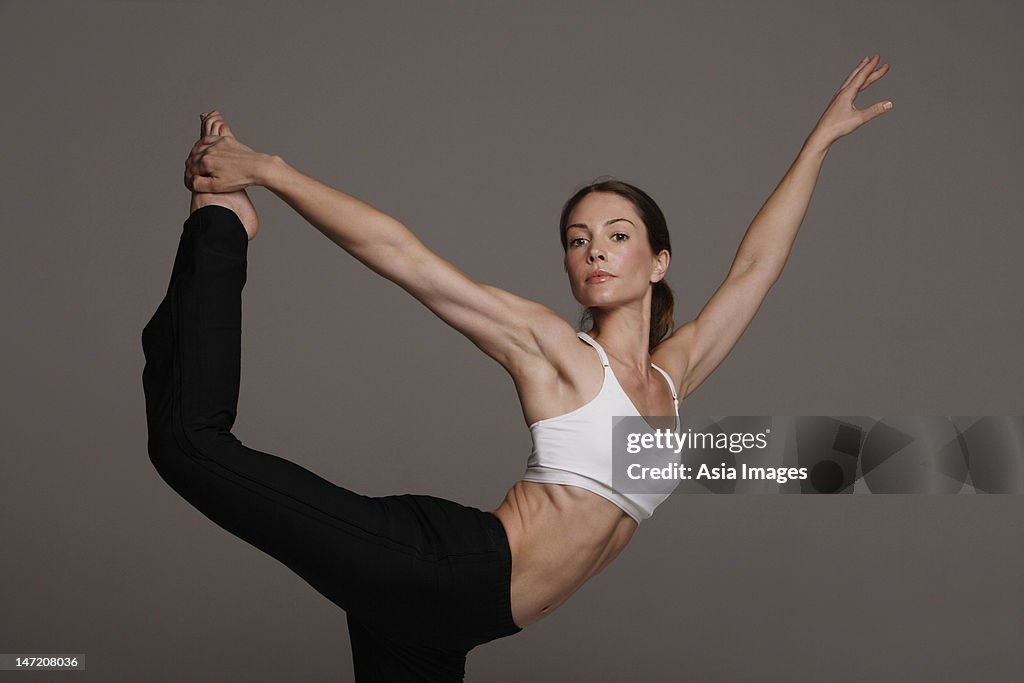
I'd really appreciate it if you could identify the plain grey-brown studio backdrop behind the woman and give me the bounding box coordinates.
[0,1,1024,681]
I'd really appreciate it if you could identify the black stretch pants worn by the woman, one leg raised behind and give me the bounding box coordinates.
[142,206,520,681]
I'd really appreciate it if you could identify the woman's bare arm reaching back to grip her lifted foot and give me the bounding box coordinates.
[185,113,571,376]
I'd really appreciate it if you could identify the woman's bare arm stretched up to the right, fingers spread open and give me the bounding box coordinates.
[653,55,892,396]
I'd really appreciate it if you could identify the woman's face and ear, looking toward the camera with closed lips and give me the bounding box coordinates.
[565,193,669,308]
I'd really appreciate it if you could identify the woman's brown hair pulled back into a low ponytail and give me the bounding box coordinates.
[558,178,675,350]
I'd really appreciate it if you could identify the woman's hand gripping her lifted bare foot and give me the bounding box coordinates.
[184,112,271,193]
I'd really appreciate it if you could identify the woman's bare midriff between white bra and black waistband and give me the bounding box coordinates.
[492,481,637,627]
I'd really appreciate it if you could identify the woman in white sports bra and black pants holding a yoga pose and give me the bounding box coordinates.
[142,55,891,681]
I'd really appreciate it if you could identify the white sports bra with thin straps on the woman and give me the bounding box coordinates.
[522,332,679,524]
